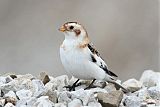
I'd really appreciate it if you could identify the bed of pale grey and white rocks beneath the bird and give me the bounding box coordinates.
[0,70,160,107]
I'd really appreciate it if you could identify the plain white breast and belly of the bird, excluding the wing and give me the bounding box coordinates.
[60,41,93,79]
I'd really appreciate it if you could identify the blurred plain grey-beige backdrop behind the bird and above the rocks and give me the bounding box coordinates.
[0,0,159,80]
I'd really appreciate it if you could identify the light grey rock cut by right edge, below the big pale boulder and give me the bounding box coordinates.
[148,86,160,100]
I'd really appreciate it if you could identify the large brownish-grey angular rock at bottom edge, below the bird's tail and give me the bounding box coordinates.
[97,90,123,107]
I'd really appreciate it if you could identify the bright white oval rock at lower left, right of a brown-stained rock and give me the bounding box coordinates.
[16,89,32,99]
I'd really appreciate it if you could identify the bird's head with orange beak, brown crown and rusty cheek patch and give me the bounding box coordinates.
[59,22,88,41]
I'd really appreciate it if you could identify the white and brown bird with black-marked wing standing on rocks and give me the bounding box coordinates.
[59,22,128,92]
